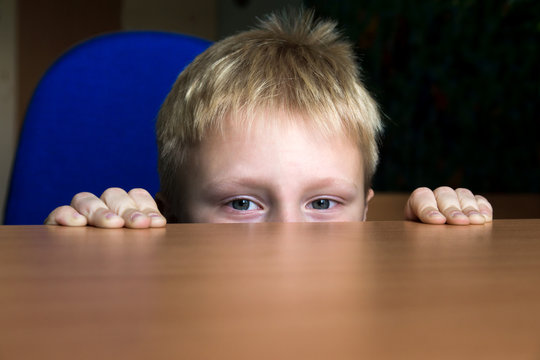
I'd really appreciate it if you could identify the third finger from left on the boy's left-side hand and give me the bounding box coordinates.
[101,188,151,229]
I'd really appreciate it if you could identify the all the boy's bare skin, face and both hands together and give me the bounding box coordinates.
[45,113,493,228]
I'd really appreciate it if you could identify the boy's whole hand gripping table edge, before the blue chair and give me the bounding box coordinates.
[45,188,167,229]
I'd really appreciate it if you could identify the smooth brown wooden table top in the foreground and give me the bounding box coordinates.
[0,219,540,359]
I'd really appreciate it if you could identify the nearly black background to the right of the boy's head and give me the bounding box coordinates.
[305,0,540,192]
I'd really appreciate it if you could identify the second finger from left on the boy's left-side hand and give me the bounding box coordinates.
[71,192,124,228]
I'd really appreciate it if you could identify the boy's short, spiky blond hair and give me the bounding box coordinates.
[157,11,382,217]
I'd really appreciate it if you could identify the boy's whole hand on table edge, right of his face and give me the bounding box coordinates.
[405,186,493,225]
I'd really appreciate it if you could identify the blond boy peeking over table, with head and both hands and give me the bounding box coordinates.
[46,9,492,228]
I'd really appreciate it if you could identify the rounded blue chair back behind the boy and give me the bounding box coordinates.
[4,31,211,224]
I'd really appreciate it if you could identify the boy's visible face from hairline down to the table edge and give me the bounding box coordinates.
[177,113,372,222]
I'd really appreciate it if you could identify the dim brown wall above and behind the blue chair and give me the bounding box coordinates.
[0,0,301,224]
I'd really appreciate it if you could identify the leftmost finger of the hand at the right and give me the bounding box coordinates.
[405,187,446,224]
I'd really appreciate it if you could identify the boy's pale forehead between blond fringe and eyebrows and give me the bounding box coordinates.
[191,111,363,185]
